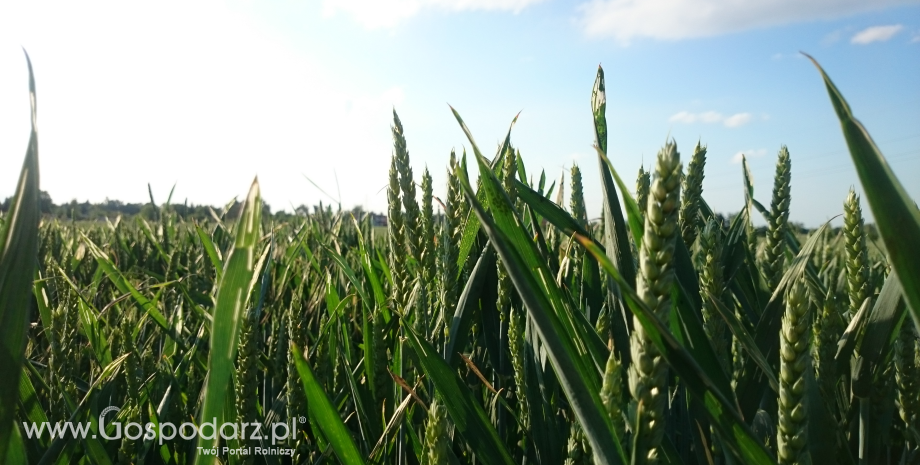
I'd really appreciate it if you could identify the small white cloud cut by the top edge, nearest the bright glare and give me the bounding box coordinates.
[323,0,542,29]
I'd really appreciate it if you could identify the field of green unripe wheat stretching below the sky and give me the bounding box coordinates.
[0,52,920,465]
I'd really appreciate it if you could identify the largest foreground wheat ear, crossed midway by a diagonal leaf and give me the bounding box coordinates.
[629,142,681,464]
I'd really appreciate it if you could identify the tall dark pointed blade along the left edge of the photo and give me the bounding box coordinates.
[0,49,41,458]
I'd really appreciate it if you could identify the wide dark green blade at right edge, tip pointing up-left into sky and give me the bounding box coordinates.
[803,54,920,331]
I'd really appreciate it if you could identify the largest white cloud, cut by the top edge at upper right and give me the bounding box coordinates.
[579,0,920,45]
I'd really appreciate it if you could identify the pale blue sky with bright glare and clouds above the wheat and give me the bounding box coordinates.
[0,0,920,226]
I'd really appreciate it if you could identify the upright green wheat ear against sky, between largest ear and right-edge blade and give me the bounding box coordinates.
[763,145,792,289]
